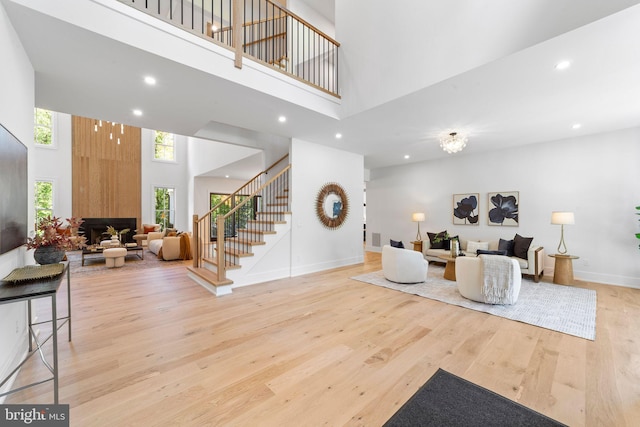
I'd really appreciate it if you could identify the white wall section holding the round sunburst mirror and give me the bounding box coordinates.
[290,139,364,276]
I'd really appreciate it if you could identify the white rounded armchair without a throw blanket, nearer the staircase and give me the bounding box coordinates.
[382,245,429,283]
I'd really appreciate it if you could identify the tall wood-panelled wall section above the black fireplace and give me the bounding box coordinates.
[71,116,142,227]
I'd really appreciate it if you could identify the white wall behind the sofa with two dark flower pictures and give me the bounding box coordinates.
[367,128,640,288]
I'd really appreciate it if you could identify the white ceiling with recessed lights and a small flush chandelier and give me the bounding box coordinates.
[0,0,640,174]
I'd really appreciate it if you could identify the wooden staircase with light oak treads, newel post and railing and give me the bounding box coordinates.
[188,155,291,296]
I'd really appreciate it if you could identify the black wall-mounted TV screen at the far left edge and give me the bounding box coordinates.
[0,125,28,254]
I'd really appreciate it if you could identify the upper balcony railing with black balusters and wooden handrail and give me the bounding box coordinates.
[119,0,340,96]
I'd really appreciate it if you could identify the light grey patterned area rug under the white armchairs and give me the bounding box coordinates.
[352,265,596,341]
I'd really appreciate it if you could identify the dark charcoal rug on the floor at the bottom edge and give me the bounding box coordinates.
[384,369,565,427]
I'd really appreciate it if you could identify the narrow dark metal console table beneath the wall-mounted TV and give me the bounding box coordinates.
[0,261,71,404]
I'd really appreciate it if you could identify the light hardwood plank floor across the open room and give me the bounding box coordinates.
[6,253,640,426]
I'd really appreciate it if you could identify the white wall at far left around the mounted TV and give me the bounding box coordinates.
[0,0,35,402]
